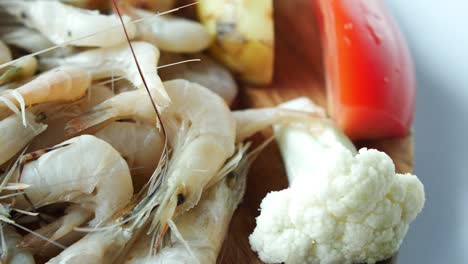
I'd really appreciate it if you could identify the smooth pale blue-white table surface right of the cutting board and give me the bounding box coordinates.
[386,0,468,264]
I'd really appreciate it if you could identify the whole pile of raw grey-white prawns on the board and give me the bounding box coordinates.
[0,0,321,263]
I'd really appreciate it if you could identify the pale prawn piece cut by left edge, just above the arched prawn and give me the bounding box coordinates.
[0,111,47,165]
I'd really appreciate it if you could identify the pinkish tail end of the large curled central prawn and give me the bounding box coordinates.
[65,108,118,136]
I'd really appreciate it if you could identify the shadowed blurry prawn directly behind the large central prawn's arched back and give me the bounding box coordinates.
[159,53,238,105]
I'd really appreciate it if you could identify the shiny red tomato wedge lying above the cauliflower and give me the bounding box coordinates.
[312,0,416,139]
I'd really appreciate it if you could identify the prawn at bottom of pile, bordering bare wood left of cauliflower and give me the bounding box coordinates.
[125,144,250,264]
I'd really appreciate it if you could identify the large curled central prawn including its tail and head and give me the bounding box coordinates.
[61,80,235,260]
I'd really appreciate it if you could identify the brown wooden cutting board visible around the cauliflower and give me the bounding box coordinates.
[218,0,413,264]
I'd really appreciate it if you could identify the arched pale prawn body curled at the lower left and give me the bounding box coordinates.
[17,135,133,225]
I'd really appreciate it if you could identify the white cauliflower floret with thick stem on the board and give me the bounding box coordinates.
[250,97,425,263]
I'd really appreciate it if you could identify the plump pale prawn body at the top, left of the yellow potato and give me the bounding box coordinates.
[131,9,211,53]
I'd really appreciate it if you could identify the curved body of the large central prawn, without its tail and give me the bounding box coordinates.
[162,80,236,212]
